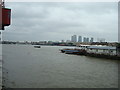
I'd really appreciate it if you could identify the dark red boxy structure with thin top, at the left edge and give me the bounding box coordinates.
[0,0,11,30]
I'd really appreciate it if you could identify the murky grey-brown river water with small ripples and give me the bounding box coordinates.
[2,45,118,88]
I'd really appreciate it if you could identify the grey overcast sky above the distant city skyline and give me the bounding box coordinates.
[3,2,118,41]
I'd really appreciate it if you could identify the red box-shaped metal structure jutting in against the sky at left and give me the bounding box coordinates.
[1,1,11,30]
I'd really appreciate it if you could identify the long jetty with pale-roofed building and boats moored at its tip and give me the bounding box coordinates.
[60,45,120,60]
